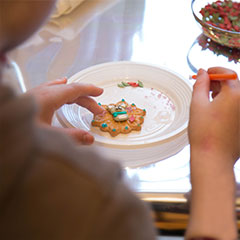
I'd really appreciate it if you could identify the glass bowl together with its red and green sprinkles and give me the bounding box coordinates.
[191,0,240,48]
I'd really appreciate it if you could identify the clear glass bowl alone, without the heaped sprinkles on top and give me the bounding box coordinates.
[191,0,240,48]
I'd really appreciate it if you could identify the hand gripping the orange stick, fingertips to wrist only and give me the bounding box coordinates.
[188,67,240,166]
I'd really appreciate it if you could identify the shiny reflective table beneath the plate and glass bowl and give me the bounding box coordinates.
[10,0,240,230]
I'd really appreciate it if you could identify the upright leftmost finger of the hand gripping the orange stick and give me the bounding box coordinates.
[192,69,210,103]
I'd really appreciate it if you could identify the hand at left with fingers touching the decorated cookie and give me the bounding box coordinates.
[26,78,103,144]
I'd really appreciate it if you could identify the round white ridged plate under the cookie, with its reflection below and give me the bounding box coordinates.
[57,62,192,166]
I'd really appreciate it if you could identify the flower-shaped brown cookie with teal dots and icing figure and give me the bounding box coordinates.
[92,99,146,137]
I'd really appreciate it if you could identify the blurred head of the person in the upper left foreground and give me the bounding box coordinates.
[0,0,56,55]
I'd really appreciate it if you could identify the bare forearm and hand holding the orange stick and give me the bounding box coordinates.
[186,67,240,240]
